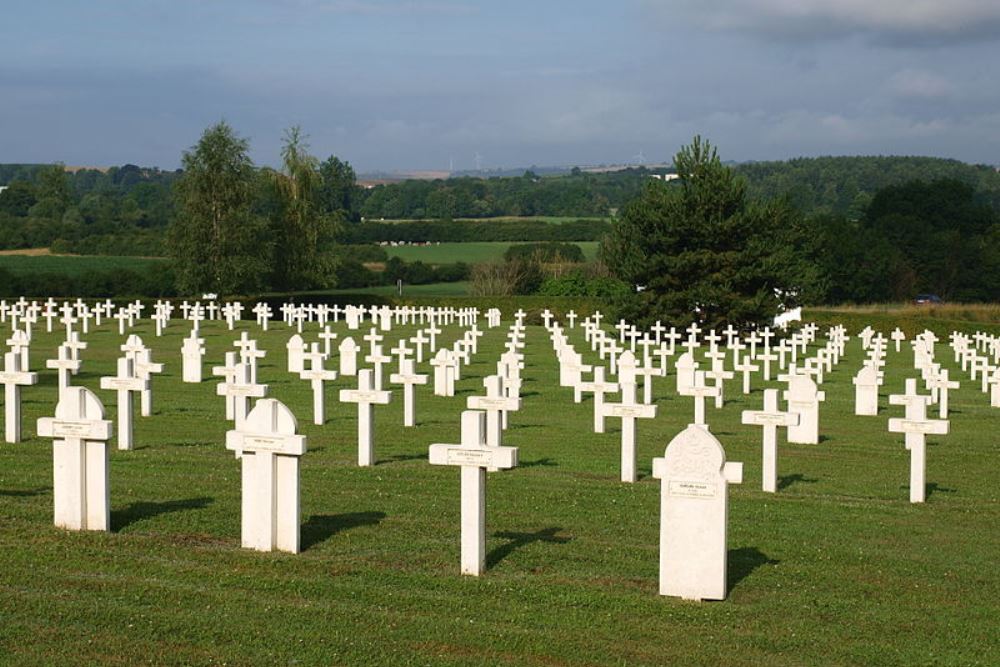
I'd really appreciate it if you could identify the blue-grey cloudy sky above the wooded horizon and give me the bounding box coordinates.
[0,0,1000,172]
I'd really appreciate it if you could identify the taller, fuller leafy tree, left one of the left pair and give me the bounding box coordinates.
[169,121,268,294]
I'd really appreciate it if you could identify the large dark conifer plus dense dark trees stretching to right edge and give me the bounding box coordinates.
[601,137,1000,327]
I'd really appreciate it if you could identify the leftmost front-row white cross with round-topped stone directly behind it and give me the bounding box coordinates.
[37,387,112,531]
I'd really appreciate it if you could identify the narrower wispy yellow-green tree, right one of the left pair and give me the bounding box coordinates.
[269,126,335,290]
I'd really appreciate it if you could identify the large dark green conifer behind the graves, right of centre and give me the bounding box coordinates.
[602,136,809,328]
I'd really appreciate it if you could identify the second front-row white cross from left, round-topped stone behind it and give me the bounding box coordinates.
[226,398,306,553]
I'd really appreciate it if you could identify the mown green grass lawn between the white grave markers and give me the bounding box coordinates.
[0,319,1000,665]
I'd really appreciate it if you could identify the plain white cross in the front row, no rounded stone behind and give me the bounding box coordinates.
[428,410,517,577]
